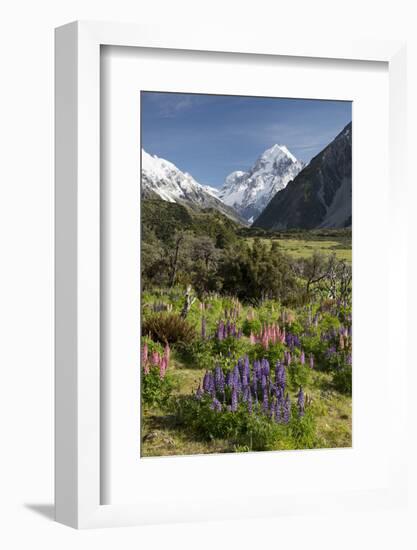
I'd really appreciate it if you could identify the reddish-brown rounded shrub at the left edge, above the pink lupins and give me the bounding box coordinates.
[142,312,196,344]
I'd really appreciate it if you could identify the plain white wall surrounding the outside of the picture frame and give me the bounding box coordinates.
[0,0,417,550]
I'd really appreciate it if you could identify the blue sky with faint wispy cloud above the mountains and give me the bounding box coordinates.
[141,92,352,187]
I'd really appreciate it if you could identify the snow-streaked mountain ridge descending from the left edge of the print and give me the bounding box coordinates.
[141,149,244,223]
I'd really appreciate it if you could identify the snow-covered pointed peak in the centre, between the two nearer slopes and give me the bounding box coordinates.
[218,148,304,223]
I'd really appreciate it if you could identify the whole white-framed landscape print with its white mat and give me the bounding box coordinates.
[56,22,406,528]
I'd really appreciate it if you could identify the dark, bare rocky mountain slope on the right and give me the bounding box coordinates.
[254,122,352,230]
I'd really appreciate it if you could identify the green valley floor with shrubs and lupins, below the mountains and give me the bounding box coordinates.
[140,200,352,457]
